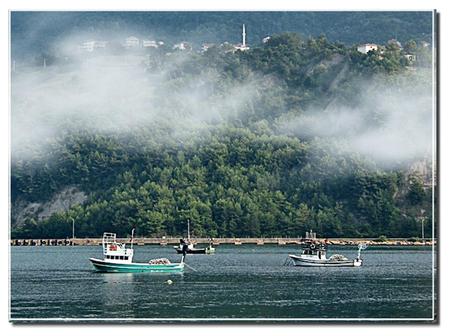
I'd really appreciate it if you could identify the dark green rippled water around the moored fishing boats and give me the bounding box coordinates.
[11,245,433,319]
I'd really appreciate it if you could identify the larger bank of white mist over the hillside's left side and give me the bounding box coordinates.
[12,35,259,161]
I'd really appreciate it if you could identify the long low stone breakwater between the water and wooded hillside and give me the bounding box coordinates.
[11,237,436,246]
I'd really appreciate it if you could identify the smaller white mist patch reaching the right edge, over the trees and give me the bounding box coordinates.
[278,74,433,166]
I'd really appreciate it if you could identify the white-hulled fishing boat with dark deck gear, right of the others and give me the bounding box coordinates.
[289,240,367,267]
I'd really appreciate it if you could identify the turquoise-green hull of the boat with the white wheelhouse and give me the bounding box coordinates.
[89,258,184,273]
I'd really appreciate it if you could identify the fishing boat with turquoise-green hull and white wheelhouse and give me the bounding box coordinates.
[89,229,186,273]
